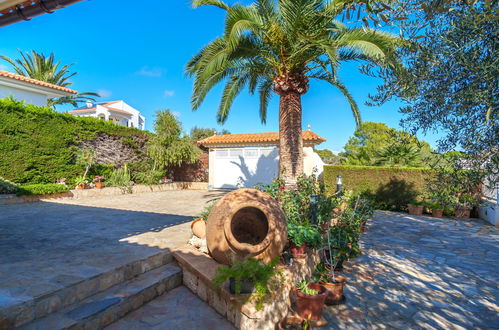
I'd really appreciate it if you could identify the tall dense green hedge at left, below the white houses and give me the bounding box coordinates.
[0,99,150,184]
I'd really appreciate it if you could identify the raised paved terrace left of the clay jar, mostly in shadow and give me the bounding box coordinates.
[0,190,222,320]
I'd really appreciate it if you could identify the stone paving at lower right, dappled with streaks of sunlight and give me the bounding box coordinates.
[325,211,499,329]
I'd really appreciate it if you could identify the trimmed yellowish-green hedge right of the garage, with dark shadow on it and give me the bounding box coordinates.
[324,165,435,210]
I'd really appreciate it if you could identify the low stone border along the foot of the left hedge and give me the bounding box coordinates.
[0,182,208,205]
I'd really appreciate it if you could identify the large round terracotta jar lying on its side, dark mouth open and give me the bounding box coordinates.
[206,189,288,265]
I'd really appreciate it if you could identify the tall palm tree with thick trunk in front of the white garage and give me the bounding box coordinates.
[186,0,398,186]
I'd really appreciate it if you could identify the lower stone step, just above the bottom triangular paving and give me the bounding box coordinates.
[21,263,182,330]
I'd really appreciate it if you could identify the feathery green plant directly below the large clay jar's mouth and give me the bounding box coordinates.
[213,257,280,310]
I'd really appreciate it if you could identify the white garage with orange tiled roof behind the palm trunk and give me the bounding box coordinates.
[198,130,326,189]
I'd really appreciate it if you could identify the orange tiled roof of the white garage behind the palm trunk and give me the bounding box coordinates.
[198,131,326,147]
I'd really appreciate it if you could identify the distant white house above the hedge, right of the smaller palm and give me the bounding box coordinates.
[68,101,146,129]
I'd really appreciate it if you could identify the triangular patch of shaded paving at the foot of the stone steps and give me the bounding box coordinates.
[105,286,234,330]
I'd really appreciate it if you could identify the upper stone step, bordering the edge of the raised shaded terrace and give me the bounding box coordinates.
[0,251,173,328]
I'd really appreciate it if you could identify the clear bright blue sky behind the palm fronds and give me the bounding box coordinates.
[0,0,442,150]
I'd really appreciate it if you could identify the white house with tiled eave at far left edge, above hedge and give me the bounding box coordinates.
[0,70,78,106]
